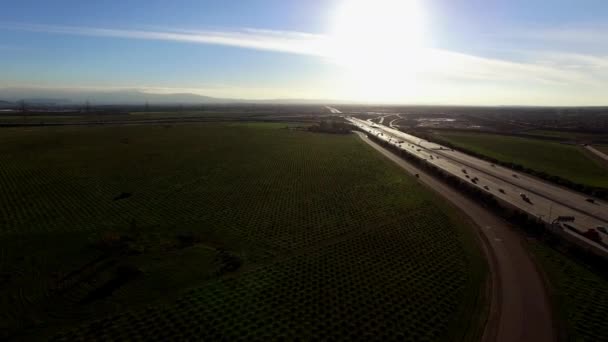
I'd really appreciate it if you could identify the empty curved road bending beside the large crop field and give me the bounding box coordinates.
[357,132,556,342]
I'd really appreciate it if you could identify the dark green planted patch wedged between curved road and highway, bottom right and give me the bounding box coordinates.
[531,242,608,342]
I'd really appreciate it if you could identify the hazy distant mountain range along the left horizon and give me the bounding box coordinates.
[0,88,331,107]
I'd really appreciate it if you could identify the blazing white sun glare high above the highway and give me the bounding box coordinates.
[328,0,428,100]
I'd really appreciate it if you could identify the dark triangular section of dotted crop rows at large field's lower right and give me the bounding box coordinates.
[51,204,472,341]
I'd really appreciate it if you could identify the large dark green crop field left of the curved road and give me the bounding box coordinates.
[0,123,486,341]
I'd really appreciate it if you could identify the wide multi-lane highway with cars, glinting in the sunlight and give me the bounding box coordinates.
[346,117,608,255]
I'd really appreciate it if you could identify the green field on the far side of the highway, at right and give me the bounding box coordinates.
[432,132,608,188]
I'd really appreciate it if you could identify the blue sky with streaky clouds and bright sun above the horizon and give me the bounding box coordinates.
[0,0,608,106]
